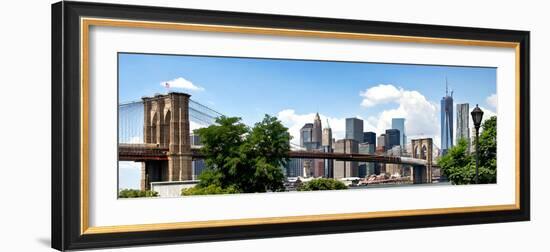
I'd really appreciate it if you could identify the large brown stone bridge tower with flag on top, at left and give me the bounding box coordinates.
[141,92,192,190]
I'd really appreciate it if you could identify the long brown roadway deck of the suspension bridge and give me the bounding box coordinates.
[118,144,428,166]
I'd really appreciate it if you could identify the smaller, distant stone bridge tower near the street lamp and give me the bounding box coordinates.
[411,138,433,184]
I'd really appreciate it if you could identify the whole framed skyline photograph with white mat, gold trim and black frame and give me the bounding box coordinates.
[52,1,530,250]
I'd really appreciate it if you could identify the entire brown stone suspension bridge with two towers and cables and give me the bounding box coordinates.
[118,92,433,190]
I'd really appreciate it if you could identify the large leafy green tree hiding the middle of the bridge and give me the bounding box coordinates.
[182,115,290,195]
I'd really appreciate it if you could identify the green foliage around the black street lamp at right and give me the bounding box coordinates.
[438,116,497,185]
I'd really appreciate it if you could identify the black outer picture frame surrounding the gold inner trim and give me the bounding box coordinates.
[51,1,530,250]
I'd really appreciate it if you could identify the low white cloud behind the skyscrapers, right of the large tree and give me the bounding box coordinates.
[277,109,374,145]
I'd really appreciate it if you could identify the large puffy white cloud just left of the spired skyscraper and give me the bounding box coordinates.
[360,84,440,145]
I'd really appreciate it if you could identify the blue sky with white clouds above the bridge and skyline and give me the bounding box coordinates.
[119,53,497,189]
